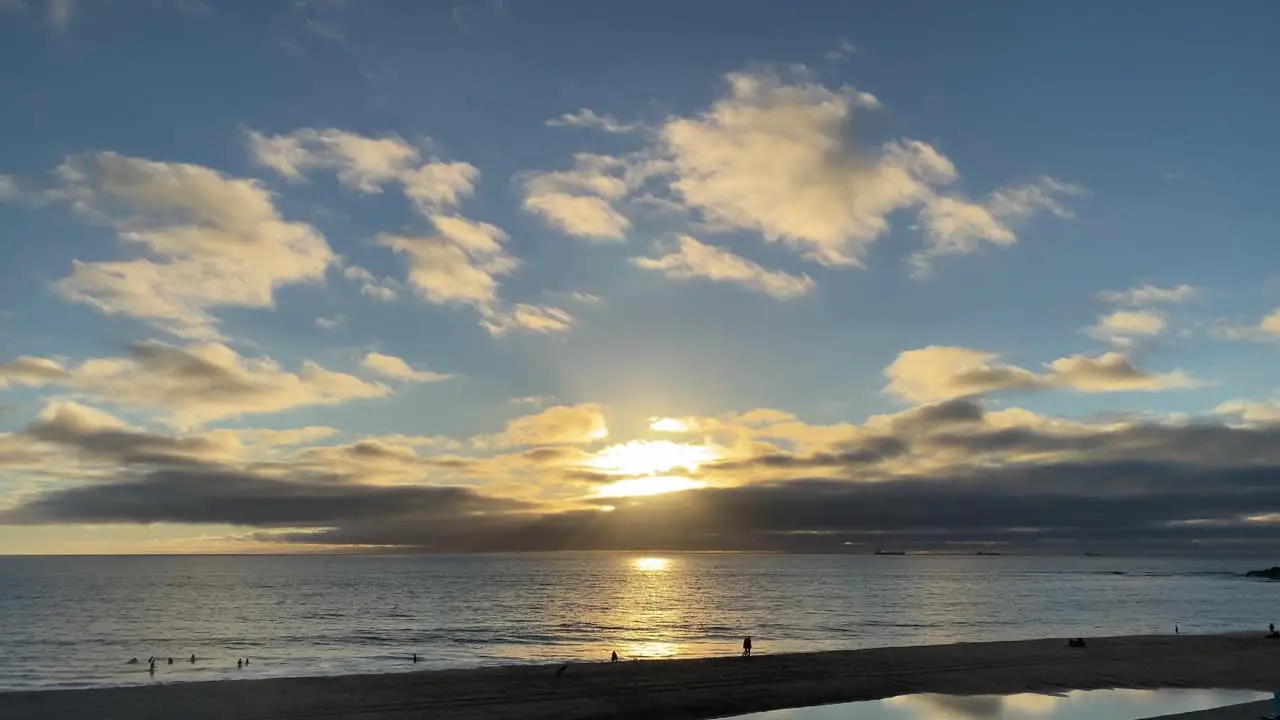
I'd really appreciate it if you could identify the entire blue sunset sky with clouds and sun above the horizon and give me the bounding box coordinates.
[0,0,1280,553]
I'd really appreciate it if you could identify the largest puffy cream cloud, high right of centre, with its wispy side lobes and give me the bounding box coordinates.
[524,68,1083,274]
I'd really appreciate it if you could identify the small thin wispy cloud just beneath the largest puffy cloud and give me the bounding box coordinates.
[631,234,813,300]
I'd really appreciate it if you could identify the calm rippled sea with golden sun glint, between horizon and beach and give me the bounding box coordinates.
[0,553,1280,689]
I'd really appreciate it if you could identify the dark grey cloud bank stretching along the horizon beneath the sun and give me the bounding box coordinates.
[0,394,1280,555]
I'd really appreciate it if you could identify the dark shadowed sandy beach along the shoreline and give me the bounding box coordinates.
[0,633,1280,720]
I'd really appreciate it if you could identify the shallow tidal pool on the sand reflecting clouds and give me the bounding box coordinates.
[737,688,1271,720]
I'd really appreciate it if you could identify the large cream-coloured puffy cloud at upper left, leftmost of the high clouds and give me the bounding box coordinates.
[54,152,335,340]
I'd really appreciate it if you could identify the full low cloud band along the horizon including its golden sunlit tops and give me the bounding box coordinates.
[12,392,1280,552]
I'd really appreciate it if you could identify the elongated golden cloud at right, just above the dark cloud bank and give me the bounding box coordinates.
[884,346,1198,402]
